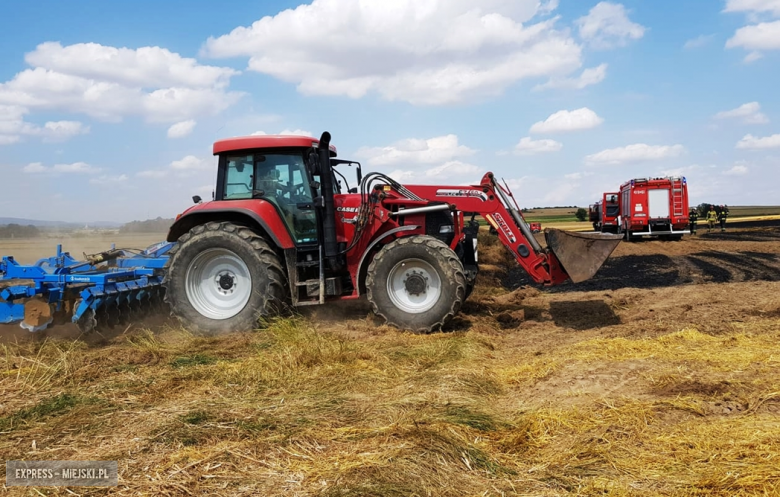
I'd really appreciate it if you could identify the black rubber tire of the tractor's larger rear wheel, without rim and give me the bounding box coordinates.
[163,222,287,335]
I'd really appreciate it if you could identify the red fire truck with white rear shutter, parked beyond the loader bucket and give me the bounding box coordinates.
[618,177,690,240]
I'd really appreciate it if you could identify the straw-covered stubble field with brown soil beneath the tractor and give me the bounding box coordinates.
[0,223,780,496]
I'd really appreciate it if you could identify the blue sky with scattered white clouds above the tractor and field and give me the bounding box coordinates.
[0,0,780,222]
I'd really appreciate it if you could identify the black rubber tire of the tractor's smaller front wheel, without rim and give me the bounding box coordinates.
[366,235,467,333]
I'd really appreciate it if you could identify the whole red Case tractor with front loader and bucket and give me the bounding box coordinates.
[163,132,620,333]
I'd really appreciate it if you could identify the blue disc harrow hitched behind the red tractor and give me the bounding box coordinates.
[0,242,174,333]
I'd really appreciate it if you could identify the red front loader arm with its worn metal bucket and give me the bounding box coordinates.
[408,173,621,286]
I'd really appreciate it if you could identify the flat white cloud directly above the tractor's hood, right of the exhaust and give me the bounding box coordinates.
[355,135,476,166]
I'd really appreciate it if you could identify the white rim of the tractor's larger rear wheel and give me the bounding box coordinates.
[185,248,252,319]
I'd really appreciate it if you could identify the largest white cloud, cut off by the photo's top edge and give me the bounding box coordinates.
[202,0,582,105]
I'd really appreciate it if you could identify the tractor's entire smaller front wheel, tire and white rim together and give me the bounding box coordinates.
[366,235,466,333]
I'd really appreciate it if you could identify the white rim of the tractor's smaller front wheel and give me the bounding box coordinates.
[387,259,442,314]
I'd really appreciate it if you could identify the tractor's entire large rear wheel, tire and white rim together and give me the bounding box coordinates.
[163,222,286,335]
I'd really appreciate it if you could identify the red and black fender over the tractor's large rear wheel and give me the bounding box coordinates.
[167,204,295,249]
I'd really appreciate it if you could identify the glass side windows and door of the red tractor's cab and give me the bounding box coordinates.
[223,152,317,243]
